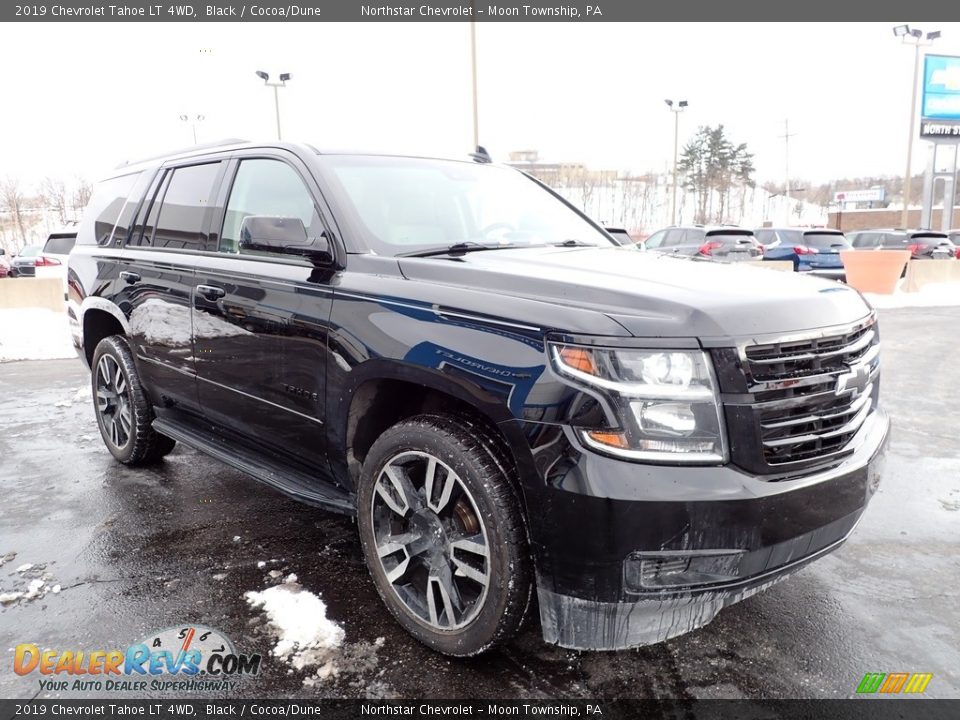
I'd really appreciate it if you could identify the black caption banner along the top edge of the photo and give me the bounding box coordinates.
[0,0,960,22]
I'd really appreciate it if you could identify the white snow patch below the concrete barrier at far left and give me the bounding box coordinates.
[0,308,77,362]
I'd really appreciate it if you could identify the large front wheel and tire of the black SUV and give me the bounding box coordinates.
[357,415,532,657]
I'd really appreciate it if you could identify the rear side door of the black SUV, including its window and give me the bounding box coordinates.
[117,160,225,414]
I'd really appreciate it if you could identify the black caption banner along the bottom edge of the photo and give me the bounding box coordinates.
[0,698,960,720]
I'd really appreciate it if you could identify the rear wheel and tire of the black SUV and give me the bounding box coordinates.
[90,335,176,465]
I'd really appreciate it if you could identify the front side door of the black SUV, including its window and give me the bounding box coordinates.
[193,151,333,467]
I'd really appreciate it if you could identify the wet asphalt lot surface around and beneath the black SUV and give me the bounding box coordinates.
[0,308,960,699]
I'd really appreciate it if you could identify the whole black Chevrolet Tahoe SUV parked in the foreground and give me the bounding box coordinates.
[68,143,889,656]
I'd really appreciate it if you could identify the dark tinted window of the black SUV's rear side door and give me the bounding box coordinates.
[144,162,220,249]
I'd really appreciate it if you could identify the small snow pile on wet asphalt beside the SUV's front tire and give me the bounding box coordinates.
[244,574,344,682]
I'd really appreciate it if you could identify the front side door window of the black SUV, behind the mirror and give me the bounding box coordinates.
[218,160,323,252]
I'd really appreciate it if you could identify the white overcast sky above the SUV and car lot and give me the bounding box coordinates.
[0,18,960,182]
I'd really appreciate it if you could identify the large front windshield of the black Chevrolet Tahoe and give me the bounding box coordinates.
[322,155,611,255]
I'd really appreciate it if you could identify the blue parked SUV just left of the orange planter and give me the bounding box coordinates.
[753,228,850,280]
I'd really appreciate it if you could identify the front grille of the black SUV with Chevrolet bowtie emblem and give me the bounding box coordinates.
[728,318,880,473]
